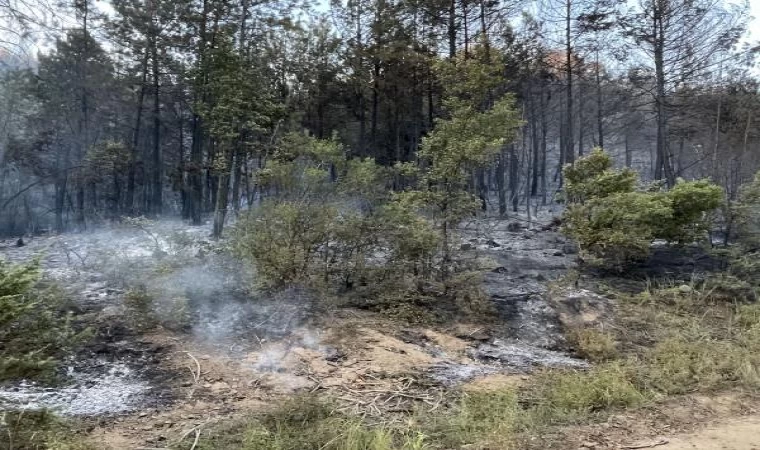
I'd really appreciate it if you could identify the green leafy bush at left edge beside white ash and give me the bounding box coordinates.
[0,260,88,381]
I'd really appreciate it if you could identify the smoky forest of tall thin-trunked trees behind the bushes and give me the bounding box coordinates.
[0,0,759,236]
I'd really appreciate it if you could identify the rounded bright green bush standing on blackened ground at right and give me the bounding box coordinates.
[563,149,722,269]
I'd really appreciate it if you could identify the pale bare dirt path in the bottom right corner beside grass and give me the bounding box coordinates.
[657,415,760,450]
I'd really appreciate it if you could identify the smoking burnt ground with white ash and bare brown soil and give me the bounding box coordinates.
[0,220,748,449]
